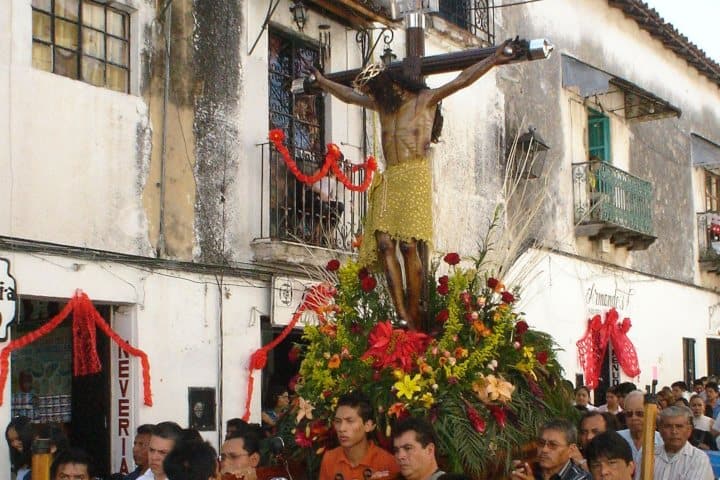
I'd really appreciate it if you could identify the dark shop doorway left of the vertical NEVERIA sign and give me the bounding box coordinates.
[11,298,111,477]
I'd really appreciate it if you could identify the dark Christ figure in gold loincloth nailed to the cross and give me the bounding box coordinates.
[292,3,552,329]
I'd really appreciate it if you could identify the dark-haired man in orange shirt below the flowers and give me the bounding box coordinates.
[319,392,399,480]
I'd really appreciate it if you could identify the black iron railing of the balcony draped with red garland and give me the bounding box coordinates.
[259,143,366,251]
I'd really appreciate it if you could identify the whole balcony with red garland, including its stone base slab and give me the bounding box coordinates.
[253,143,366,265]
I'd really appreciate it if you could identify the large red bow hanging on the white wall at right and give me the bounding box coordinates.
[576,308,640,389]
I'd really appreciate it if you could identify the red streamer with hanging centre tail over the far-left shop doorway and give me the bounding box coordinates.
[0,290,152,406]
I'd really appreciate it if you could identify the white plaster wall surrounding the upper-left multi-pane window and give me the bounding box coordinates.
[0,0,156,254]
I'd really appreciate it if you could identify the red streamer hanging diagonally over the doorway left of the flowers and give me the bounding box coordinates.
[242,283,337,422]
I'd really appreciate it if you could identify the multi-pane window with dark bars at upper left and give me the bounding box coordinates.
[32,0,130,93]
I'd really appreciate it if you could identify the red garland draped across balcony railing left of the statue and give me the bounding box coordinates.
[268,128,377,192]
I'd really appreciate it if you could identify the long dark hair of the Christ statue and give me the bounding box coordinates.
[367,70,444,143]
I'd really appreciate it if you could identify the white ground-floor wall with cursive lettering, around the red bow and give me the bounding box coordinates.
[518,250,720,387]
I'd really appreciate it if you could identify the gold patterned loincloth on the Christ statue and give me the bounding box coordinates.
[358,158,433,270]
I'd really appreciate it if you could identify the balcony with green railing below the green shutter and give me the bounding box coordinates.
[572,161,656,250]
